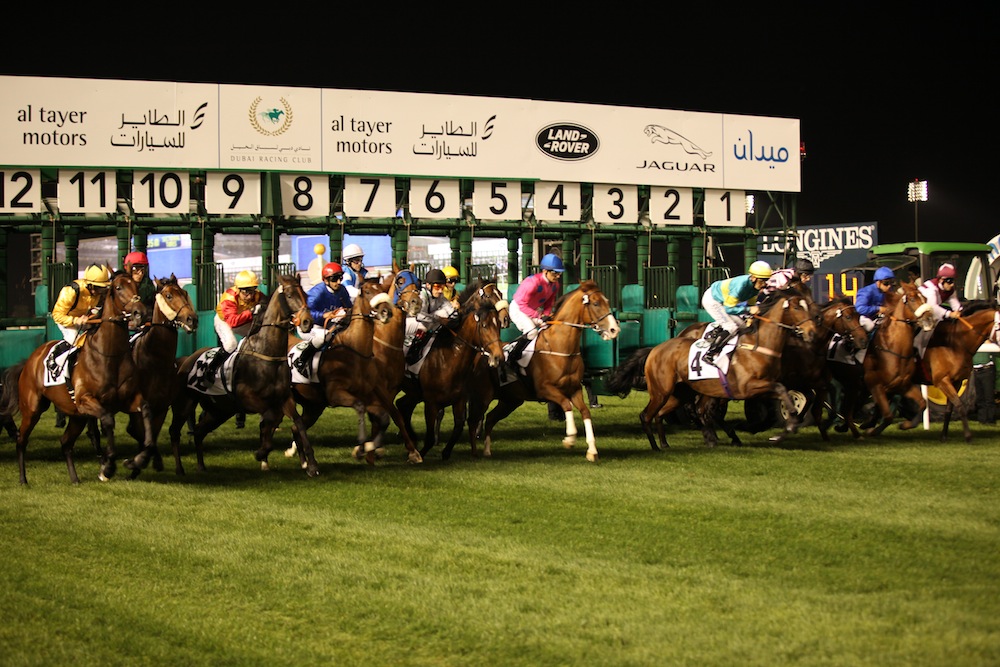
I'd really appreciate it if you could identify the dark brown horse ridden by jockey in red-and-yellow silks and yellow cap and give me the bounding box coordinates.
[170,275,319,477]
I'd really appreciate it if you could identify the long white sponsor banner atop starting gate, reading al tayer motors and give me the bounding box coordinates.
[0,76,800,192]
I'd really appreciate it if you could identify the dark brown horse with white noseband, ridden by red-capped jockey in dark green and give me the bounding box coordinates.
[125,274,198,479]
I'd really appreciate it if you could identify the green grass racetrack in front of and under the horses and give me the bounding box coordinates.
[0,393,1000,667]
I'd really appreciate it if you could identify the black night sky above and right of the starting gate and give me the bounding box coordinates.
[0,3,1000,243]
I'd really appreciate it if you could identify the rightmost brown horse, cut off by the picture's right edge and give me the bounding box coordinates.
[917,301,1000,442]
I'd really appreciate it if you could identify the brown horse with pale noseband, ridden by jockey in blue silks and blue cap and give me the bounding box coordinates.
[856,283,934,437]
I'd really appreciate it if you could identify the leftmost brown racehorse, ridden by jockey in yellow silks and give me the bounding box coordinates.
[0,272,146,484]
